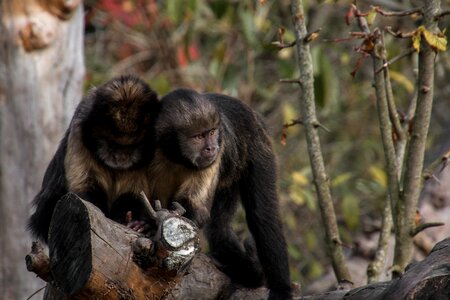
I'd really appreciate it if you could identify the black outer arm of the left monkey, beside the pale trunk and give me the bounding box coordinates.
[27,132,68,243]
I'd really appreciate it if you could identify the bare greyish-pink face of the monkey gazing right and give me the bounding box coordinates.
[178,128,220,169]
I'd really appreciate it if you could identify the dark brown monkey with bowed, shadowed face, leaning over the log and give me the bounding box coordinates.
[28,76,159,242]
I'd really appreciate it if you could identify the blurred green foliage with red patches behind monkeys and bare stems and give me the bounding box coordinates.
[85,0,450,287]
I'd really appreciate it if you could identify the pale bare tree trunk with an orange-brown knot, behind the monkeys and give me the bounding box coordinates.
[0,0,84,299]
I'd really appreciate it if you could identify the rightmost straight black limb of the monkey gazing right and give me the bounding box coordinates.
[241,157,292,299]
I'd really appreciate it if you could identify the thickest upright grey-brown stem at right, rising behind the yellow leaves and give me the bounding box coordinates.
[394,0,440,275]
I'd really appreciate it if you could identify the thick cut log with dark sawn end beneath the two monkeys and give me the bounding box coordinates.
[27,193,268,300]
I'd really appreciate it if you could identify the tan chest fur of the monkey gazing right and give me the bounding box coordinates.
[149,149,221,210]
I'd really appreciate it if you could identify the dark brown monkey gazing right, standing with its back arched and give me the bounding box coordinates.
[150,89,292,299]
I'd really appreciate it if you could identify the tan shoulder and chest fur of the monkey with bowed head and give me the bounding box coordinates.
[64,118,151,207]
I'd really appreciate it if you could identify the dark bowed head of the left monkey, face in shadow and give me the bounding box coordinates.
[82,75,159,169]
